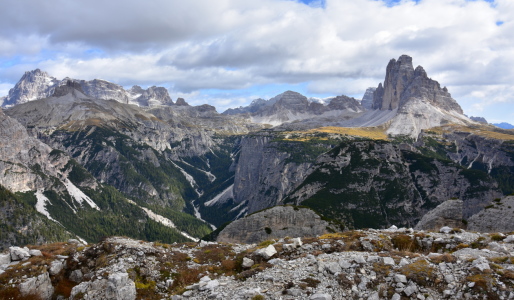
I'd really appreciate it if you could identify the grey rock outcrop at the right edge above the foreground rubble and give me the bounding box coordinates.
[468,196,514,232]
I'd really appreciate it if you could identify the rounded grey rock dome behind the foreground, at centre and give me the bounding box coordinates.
[217,206,329,243]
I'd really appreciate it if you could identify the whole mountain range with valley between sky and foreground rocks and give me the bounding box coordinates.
[0,55,514,247]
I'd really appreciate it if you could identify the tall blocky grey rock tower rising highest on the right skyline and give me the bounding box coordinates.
[372,55,463,114]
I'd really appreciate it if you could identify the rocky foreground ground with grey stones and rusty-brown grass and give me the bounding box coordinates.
[0,226,514,300]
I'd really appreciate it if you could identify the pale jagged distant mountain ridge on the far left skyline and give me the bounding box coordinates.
[0,69,174,107]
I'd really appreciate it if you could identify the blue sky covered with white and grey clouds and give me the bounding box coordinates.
[0,0,514,123]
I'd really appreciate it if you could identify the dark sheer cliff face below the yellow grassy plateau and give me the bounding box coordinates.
[233,135,501,228]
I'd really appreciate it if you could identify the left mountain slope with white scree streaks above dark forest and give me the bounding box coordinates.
[0,91,209,245]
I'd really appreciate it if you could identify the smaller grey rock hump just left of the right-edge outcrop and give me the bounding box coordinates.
[414,200,464,230]
